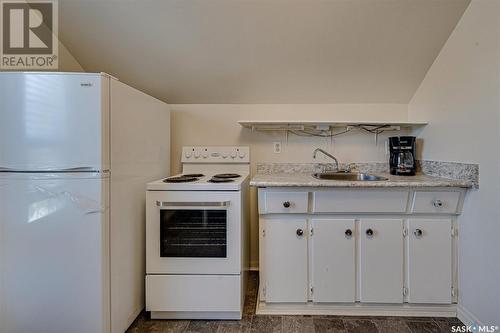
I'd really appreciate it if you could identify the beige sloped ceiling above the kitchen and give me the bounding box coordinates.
[59,0,469,103]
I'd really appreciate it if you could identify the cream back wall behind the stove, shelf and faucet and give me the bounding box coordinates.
[171,104,408,267]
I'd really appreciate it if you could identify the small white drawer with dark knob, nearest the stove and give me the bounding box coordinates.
[261,192,309,213]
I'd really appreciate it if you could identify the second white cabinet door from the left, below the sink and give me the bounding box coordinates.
[311,219,356,302]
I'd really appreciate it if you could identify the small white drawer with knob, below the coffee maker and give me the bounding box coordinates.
[411,191,461,214]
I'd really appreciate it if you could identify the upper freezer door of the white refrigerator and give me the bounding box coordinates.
[0,73,109,171]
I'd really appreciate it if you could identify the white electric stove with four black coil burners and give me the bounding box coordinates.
[146,146,250,319]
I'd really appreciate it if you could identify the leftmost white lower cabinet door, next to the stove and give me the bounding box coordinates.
[263,219,308,302]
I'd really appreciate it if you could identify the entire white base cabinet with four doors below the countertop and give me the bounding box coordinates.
[257,187,465,316]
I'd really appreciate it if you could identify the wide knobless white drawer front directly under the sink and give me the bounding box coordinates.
[313,189,409,213]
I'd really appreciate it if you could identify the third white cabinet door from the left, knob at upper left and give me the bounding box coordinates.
[359,219,403,303]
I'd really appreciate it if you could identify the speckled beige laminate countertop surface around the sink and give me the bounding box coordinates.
[250,173,473,188]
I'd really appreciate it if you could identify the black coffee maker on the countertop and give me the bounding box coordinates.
[389,136,417,176]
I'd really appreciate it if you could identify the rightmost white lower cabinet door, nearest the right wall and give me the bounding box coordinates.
[408,219,452,304]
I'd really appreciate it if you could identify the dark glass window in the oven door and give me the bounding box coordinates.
[160,209,227,258]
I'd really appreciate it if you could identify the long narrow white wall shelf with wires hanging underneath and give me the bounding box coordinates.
[238,120,427,144]
